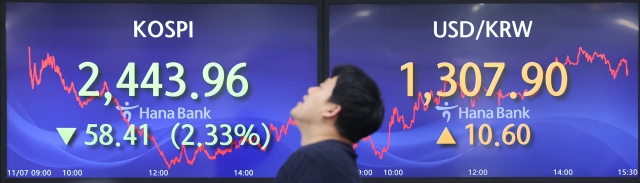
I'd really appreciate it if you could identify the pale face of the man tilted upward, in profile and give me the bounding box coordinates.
[291,76,340,123]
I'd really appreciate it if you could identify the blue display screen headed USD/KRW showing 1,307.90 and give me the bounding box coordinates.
[328,3,638,177]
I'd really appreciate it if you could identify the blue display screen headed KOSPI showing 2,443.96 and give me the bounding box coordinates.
[2,3,318,179]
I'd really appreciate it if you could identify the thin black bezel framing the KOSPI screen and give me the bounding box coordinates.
[0,0,324,183]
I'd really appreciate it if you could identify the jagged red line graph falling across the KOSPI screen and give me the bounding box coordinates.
[28,47,296,169]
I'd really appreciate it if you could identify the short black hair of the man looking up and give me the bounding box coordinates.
[329,64,384,143]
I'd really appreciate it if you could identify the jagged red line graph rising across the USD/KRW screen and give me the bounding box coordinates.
[353,47,629,159]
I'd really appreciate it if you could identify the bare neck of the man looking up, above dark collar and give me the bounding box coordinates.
[298,121,353,146]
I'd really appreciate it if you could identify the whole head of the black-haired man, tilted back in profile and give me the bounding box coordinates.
[291,65,384,143]
